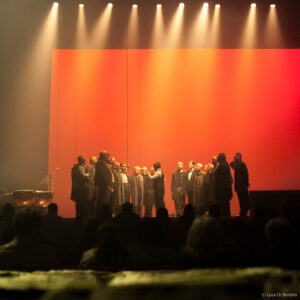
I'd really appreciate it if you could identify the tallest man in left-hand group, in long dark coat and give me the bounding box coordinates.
[95,151,115,207]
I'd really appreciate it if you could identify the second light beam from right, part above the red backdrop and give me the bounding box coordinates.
[241,3,257,48]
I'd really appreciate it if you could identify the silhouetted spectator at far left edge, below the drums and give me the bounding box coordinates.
[0,203,15,245]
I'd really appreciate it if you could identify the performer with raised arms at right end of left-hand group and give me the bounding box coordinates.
[149,161,165,212]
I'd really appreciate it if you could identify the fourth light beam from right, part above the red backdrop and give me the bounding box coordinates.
[188,5,208,48]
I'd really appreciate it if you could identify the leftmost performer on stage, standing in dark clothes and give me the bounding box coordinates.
[71,156,90,219]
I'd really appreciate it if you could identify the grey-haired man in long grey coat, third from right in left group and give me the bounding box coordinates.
[130,166,144,217]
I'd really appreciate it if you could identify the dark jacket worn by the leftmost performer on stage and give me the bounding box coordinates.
[71,164,89,201]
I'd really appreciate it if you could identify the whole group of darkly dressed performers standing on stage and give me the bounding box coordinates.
[71,151,250,219]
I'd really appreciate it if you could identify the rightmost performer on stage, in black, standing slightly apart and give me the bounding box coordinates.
[230,153,250,216]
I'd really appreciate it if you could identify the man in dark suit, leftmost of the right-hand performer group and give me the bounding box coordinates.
[171,161,187,217]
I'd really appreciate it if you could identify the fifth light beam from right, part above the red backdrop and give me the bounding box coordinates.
[166,3,184,48]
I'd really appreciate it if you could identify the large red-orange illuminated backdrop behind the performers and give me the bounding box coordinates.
[49,49,300,217]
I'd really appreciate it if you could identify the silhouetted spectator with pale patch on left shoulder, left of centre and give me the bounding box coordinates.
[80,222,128,269]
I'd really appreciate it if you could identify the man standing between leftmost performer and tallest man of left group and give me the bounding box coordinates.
[86,156,97,217]
